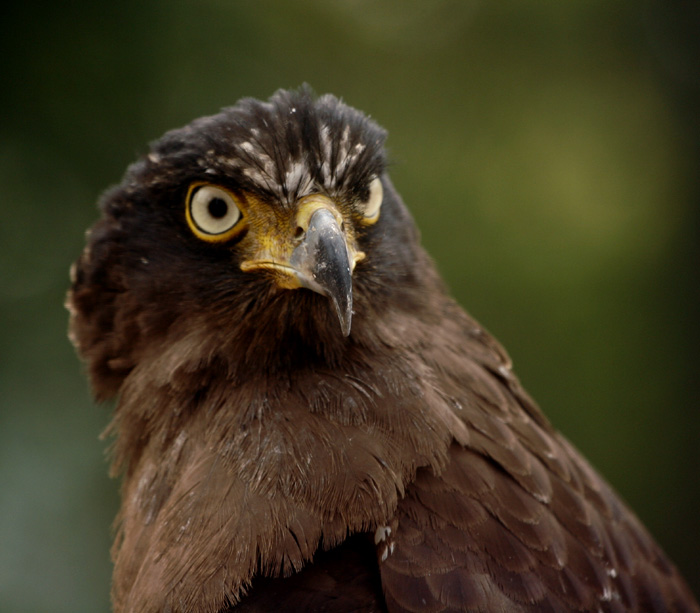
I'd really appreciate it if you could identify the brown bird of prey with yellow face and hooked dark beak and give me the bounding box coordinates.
[68,88,700,613]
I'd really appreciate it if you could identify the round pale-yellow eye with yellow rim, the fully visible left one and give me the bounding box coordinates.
[187,183,242,243]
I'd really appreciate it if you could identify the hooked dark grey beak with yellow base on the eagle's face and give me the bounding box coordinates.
[241,194,365,336]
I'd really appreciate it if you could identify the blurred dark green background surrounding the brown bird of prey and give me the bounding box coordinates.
[0,0,700,612]
